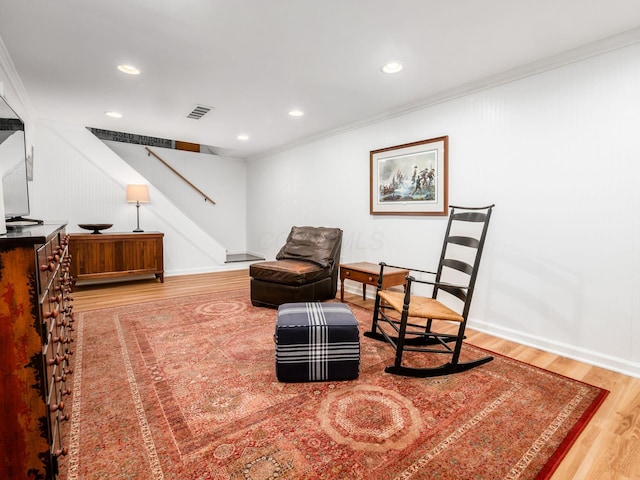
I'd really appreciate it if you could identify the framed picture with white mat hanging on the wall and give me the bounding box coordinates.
[369,135,449,215]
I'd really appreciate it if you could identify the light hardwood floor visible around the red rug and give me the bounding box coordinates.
[73,270,640,480]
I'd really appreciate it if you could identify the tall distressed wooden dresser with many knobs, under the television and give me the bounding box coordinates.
[0,225,73,479]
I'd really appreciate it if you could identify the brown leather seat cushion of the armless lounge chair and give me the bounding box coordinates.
[249,259,331,285]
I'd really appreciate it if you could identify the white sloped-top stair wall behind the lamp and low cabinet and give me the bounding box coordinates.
[30,121,235,276]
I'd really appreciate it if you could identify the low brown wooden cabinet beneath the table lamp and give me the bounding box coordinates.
[69,232,164,282]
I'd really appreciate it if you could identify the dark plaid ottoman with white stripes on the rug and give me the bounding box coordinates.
[274,302,360,382]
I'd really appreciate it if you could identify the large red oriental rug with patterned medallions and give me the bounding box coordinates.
[60,290,607,480]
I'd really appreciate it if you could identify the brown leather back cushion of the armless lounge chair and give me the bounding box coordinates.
[276,227,342,268]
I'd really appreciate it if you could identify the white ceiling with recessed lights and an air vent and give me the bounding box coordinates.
[0,0,640,158]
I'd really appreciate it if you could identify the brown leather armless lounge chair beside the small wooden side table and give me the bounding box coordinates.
[249,227,342,308]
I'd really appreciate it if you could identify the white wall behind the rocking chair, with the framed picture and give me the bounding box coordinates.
[247,44,640,376]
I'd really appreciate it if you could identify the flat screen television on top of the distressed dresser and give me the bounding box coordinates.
[0,96,39,228]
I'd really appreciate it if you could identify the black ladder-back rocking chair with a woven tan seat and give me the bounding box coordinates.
[364,205,494,377]
